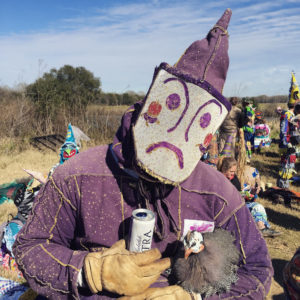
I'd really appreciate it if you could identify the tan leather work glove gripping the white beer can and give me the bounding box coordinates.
[83,240,170,295]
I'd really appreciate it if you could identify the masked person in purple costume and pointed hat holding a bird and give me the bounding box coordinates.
[14,9,273,300]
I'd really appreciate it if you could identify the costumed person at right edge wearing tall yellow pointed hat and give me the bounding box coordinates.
[277,73,300,188]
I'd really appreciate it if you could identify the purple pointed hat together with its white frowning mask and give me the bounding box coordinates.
[133,9,231,185]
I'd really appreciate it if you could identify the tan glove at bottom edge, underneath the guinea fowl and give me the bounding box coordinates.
[120,285,201,300]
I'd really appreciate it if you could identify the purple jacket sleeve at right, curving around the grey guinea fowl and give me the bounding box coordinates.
[208,205,273,300]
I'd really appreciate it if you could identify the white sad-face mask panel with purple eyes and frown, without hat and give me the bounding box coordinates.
[133,64,228,184]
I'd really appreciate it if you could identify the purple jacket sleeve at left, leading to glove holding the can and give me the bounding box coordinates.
[13,178,87,299]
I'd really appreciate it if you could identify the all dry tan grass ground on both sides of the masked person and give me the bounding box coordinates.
[0,114,300,300]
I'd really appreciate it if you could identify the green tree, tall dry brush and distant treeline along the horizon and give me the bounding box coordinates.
[0,65,287,152]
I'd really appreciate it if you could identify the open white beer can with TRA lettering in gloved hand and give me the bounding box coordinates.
[129,208,155,252]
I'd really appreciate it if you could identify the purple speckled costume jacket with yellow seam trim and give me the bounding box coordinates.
[14,104,273,300]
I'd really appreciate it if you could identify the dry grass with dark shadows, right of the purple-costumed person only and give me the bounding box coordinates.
[251,151,300,300]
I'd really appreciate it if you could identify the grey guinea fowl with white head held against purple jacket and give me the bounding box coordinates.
[172,228,239,297]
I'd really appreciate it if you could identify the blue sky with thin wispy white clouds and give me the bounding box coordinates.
[0,0,300,97]
